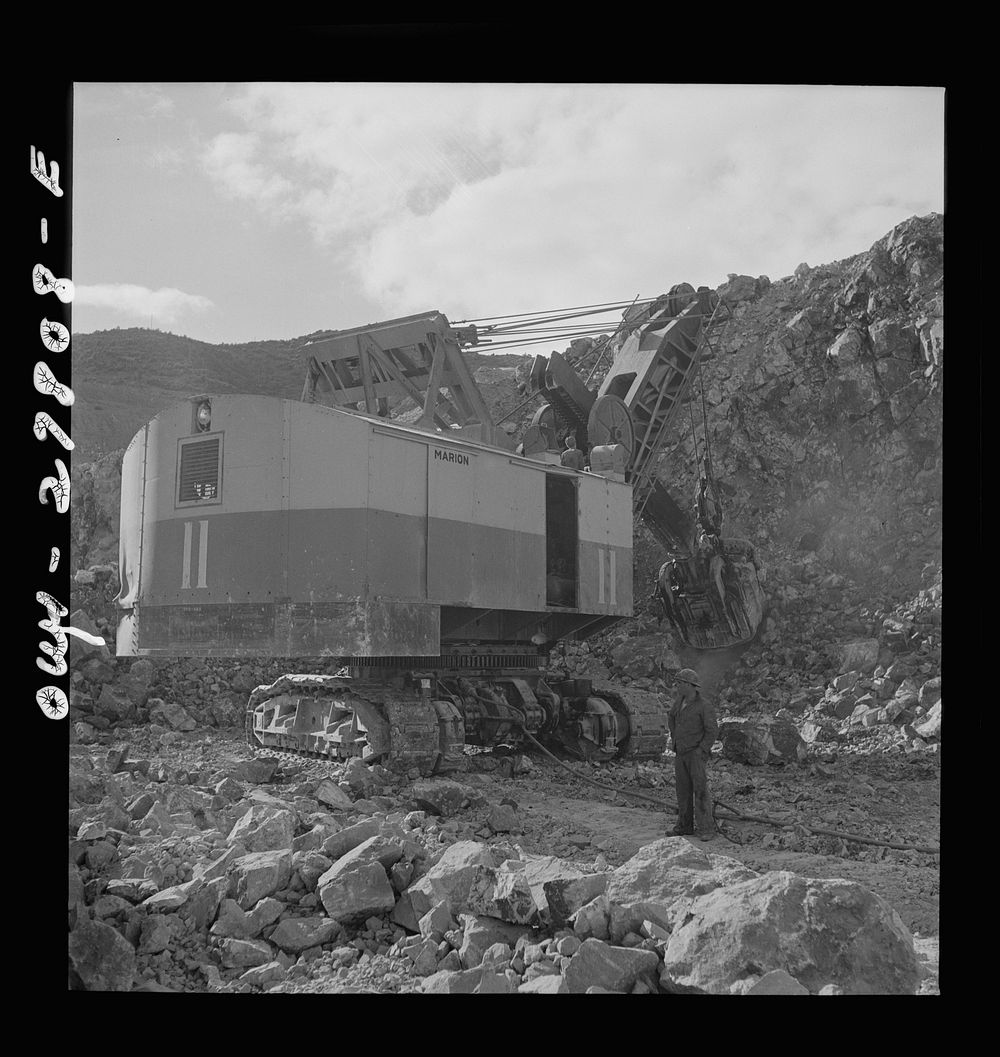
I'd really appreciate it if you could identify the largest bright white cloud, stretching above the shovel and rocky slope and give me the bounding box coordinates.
[205,84,943,318]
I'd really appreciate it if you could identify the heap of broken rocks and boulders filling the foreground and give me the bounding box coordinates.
[69,745,921,994]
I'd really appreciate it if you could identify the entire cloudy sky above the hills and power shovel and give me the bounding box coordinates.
[71,82,944,351]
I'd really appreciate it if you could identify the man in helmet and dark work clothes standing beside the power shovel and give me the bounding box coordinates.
[667,668,719,840]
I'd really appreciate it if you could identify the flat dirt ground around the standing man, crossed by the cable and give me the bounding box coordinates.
[465,757,940,937]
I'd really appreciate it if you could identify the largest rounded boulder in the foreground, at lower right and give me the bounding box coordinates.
[663,871,920,995]
